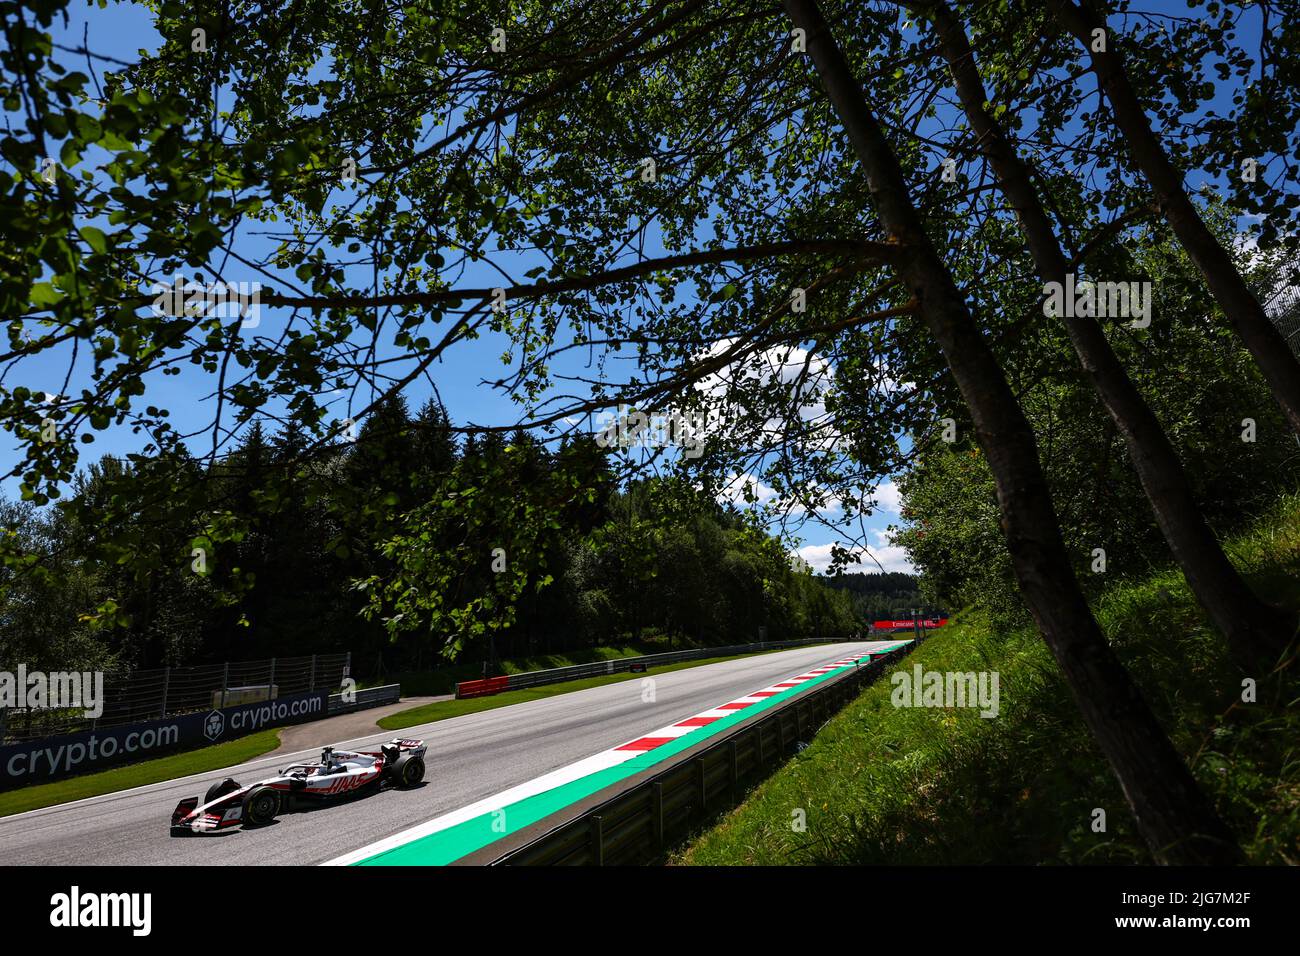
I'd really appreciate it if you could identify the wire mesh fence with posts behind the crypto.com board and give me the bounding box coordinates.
[0,653,352,744]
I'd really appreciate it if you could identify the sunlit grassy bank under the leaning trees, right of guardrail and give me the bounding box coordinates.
[671,496,1300,865]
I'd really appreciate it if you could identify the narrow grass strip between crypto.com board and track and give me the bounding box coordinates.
[0,730,280,817]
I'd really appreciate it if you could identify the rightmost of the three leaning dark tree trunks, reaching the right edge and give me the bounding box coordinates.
[1048,0,1300,432]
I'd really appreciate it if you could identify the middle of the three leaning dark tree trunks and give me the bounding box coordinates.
[918,0,1296,672]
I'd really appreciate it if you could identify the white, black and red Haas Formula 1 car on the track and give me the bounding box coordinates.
[172,740,426,836]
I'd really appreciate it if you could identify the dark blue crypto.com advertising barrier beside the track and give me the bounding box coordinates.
[0,691,329,790]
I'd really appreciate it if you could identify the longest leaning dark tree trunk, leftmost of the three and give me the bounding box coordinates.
[783,0,1243,864]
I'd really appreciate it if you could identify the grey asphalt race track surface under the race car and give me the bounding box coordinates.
[0,641,894,866]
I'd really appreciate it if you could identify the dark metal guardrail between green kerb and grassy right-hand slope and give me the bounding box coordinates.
[488,635,928,866]
